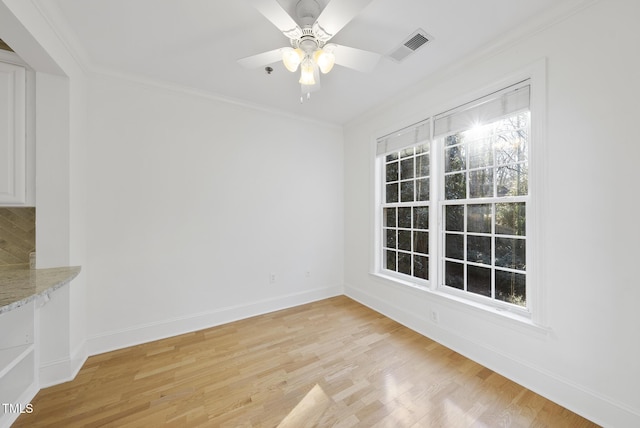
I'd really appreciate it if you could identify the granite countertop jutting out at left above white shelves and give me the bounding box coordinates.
[0,265,80,314]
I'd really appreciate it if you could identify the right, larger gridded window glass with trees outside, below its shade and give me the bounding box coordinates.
[441,111,530,307]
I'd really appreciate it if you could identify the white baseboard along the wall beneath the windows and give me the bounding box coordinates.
[345,284,640,427]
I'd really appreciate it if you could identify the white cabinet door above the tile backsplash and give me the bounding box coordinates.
[0,62,27,205]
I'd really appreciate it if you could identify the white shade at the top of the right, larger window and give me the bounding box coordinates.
[434,80,531,138]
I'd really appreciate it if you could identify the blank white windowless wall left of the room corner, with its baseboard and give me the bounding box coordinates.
[87,76,343,353]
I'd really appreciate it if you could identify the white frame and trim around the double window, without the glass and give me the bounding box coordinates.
[371,59,548,328]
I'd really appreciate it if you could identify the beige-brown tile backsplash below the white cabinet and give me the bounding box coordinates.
[0,207,36,266]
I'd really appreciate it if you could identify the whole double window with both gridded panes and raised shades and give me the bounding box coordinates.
[377,80,531,311]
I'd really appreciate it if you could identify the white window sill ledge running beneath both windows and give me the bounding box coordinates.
[371,272,552,337]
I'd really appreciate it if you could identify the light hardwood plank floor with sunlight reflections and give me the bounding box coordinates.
[14,296,596,428]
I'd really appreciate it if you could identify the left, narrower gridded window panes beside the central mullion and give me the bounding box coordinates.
[382,142,430,280]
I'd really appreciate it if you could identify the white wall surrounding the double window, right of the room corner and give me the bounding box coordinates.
[345,0,640,427]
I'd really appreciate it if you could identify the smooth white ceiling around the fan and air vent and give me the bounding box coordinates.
[36,0,568,124]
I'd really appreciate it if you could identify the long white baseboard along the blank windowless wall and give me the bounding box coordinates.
[87,286,343,355]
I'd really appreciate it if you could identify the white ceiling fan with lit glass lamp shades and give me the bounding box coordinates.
[238,0,380,102]
